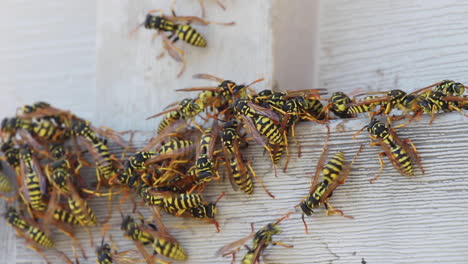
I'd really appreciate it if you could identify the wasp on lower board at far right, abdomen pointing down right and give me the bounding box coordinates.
[354,118,424,183]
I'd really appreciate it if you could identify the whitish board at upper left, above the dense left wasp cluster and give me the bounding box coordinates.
[0,0,96,120]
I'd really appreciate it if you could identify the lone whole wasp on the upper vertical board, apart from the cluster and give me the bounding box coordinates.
[130,9,235,77]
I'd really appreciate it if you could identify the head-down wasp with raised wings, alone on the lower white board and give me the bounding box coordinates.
[299,136,364,233]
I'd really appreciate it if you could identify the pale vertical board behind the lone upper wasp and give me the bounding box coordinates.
[96,0,273,130]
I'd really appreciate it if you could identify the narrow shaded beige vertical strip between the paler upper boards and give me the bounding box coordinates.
[273,0,320,91]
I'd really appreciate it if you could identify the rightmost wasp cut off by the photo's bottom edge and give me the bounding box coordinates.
[217,212,294,264]
